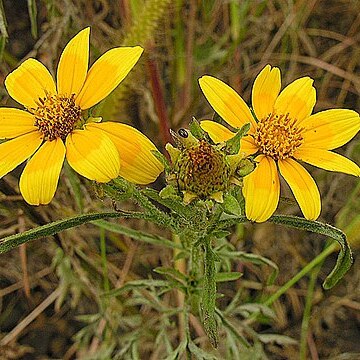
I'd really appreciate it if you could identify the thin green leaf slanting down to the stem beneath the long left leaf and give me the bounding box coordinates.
[92,220,184,250]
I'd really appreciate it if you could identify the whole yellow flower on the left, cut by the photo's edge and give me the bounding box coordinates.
[0,28,163,205]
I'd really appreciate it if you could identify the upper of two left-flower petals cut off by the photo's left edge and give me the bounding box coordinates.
[0,108,37,139]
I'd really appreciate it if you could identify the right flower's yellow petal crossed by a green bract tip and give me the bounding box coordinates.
[201,120,258,155]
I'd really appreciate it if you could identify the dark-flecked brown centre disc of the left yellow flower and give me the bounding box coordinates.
[29,94,81,141]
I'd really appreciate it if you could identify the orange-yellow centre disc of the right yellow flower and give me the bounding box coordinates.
[253,114,303,160]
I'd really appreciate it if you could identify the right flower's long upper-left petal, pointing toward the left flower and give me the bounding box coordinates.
[199,75,256,132]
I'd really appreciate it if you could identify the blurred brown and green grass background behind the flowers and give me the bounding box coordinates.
[0,0,360,360]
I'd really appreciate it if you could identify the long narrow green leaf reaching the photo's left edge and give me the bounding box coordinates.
[0,212,136,254]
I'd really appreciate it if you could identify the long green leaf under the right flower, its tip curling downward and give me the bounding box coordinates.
[269,215,353,290]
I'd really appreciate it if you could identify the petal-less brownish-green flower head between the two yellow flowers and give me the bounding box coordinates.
[163,121,255,204]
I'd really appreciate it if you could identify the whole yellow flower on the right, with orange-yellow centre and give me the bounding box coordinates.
[199,65,360,222]
